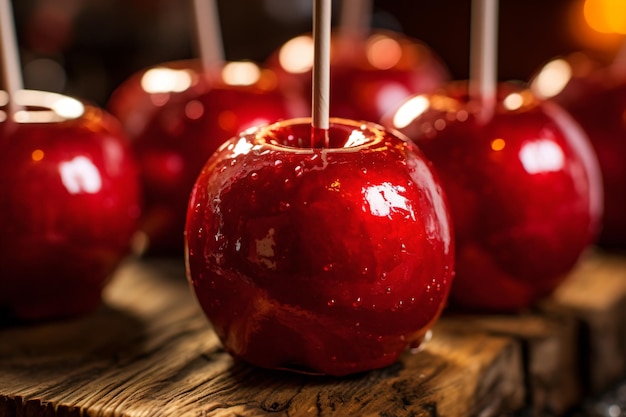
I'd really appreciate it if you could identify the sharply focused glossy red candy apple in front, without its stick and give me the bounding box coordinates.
[185,119,454,375]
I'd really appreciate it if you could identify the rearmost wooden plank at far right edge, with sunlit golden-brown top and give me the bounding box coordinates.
[541,251,626,394]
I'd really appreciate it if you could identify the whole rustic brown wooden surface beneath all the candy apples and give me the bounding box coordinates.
[0,253,626,417]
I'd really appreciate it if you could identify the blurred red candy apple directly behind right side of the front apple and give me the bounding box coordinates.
[384,83,602,311]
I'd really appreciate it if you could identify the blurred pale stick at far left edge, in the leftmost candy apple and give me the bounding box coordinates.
[0,0,24,115]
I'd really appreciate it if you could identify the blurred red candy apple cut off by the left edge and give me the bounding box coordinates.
[0,90,140,320]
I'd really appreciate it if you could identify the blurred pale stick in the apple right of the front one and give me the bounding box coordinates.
[469,0,498,122]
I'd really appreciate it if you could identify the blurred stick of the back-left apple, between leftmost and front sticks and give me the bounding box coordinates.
[193,0,224,70]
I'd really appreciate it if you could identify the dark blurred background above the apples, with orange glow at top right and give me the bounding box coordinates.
[8,0,626,105]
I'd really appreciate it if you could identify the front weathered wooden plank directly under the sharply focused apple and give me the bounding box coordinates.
[0,261,525,417]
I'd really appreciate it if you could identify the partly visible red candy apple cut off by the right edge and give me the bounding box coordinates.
[531,53,626,249]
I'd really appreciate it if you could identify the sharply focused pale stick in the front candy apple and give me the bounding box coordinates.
[312,0,332,130]
